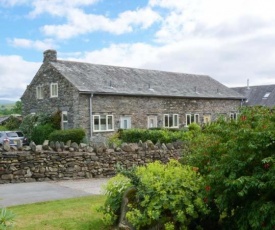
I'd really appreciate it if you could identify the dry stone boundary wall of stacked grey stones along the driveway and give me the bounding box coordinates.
[0,144,182,184]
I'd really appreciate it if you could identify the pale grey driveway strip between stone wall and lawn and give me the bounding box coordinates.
[0,178,109,208]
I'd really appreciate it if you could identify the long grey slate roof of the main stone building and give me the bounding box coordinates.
[50,60,243,99]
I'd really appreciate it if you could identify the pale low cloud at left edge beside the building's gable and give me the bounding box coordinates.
[0,56,41,100]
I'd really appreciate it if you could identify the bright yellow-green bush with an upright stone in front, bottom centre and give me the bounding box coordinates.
[103,160,208,229]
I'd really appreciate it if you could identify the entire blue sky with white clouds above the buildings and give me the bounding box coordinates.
[0,0,275,100]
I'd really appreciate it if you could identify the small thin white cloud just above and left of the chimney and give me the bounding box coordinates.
[8,38,57,51]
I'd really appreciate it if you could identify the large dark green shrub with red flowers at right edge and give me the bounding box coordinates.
[184,107,275,229]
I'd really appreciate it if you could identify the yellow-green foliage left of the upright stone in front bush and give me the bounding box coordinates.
[98,174,132,225]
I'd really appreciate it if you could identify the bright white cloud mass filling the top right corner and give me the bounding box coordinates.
[149,0,275,42]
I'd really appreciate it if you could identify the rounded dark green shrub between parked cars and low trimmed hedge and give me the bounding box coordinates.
[32,124,55,145]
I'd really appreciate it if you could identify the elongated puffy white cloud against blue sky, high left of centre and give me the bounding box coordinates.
[41,8,160,39]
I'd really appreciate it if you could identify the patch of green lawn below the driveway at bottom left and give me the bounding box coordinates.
[7,195,112,230]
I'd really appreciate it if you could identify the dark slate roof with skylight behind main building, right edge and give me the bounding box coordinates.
[232,85,275,107]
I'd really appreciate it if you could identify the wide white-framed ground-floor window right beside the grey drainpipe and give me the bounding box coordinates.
[93,115,114,132]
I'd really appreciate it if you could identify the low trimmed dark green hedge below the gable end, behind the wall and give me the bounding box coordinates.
[49,129,85,144]
